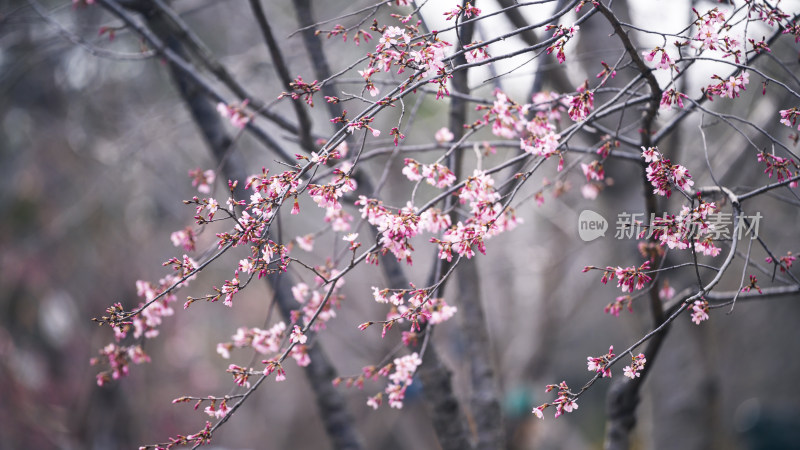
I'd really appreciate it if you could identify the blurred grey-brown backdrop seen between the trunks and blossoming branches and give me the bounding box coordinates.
[0,0,800,449]
